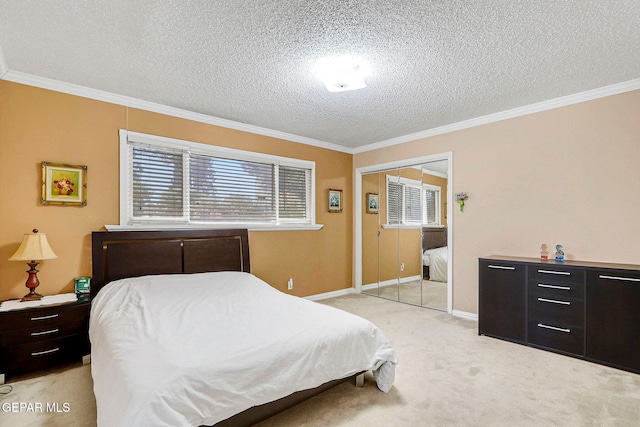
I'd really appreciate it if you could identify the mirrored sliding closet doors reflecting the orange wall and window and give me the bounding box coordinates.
[361,161,448,311]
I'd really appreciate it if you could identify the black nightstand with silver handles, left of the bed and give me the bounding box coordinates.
[0,295,91,384]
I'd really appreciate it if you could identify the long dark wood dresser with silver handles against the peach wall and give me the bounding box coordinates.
[478,256,640,373]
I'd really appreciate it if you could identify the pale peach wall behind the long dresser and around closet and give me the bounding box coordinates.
[354,90,640,313]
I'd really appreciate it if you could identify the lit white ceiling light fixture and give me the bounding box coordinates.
[314,56,367,92]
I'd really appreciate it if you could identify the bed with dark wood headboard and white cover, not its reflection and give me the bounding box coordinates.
[89,230,396,427]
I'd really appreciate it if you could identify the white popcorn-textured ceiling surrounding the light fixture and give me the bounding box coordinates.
[0,0,640,148]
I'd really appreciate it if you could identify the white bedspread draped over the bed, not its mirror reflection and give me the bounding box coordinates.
[89,272,396,427]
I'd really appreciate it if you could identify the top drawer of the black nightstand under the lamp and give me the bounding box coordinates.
[0,303,91,332]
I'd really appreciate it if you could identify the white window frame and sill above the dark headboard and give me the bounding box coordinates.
[111,129,323,231]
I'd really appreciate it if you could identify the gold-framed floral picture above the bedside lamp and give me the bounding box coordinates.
[41,162,87,206]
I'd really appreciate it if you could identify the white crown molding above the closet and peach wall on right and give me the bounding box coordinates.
[352,78,640,154]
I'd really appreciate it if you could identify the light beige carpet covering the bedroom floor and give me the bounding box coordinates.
[0,295,640,427]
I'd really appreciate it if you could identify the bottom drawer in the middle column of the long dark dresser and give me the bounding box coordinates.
[528,319,584,356]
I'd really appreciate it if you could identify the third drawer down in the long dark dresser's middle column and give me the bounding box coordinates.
[529,294,584,327]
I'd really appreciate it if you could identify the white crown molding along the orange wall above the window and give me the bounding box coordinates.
[0,70,353,154]
